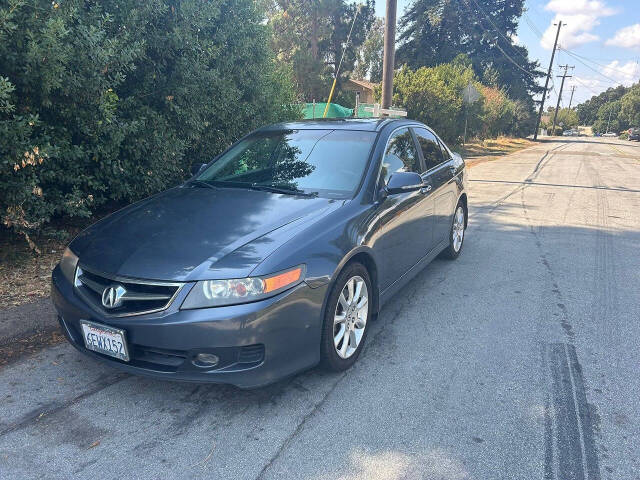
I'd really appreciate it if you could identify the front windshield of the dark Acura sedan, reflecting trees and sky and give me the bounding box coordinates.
[196,130,376,198]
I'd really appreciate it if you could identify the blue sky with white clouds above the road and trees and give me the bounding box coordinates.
[376,0,640,108]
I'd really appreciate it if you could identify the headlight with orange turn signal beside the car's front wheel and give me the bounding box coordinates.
[180,265,305,309]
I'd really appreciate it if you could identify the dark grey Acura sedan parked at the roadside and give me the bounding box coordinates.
[52,119,468,387]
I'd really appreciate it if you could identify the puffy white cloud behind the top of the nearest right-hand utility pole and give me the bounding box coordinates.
[540,0,617,50]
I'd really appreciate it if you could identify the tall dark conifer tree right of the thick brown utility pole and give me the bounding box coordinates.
[397,0,544,105]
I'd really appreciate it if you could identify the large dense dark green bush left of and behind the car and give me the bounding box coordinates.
[0,0,299,246]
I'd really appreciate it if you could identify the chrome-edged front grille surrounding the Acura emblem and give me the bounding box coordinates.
[75,266,182,317]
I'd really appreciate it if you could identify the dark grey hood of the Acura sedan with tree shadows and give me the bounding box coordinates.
[70,187,340,281]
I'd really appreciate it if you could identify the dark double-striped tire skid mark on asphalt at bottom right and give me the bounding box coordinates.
[542,343,601,480]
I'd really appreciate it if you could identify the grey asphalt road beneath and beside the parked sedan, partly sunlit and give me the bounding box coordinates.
[0,138,640,480]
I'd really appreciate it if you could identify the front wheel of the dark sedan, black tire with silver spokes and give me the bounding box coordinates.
[320,263,373,372]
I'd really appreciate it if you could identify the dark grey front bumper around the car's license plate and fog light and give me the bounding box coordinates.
[51,267,327,388]
